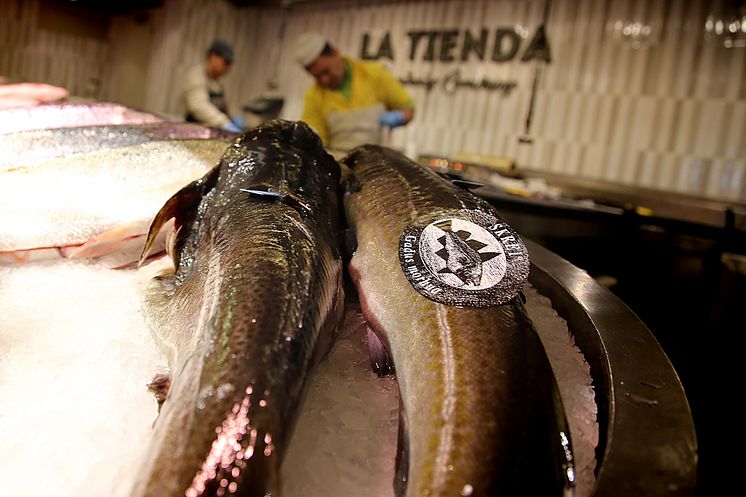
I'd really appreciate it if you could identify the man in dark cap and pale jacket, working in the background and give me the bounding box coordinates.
[182,39,245,133]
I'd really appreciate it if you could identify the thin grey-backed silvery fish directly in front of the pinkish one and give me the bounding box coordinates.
[0,122,234,171]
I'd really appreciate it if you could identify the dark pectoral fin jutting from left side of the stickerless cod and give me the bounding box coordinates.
[138,164,220,266]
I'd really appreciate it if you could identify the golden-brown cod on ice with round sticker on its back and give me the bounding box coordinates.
[343,145,573,497]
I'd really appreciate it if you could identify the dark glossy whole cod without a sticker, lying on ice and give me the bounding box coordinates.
[132,120,344,497]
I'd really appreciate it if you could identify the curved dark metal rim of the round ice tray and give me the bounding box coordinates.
[524,239,697,497]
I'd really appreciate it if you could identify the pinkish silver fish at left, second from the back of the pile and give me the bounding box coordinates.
[0,102,168,135]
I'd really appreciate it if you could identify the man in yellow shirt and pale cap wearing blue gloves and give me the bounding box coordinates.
[295,33,414,151]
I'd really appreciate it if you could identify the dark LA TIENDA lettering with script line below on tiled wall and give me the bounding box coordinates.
[360,25,551,95]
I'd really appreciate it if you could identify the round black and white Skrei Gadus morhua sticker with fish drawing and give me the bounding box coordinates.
[399,210,529,307]
